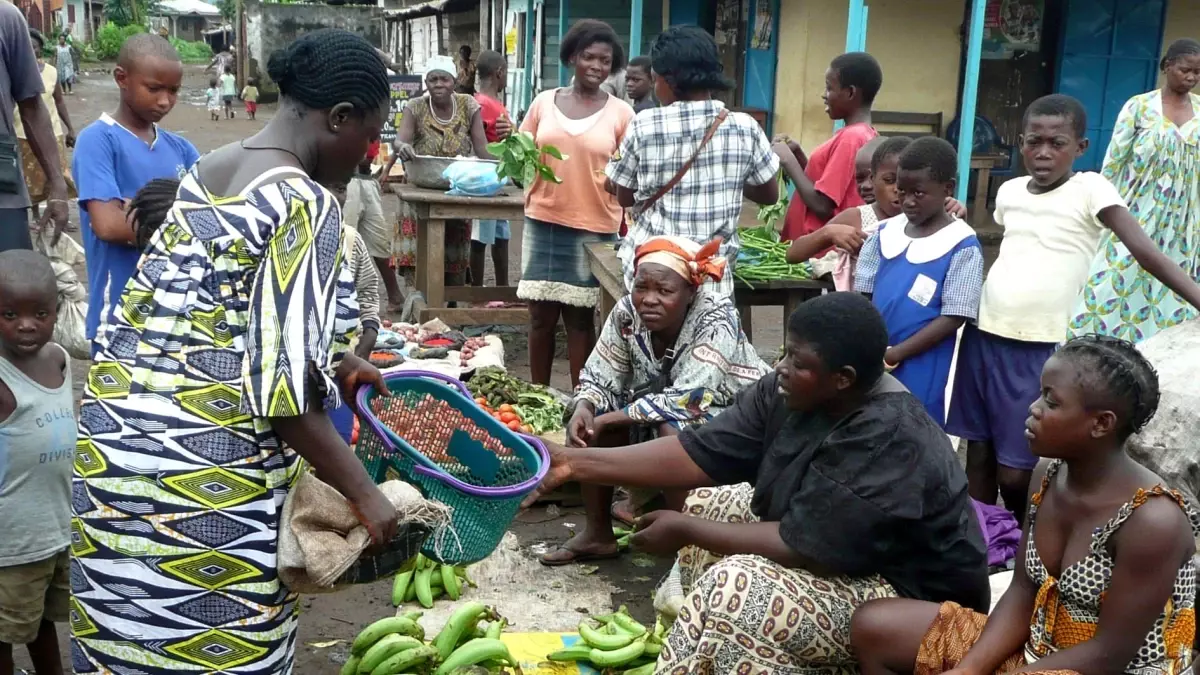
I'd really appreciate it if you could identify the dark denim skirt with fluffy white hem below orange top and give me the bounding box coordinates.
[517,217,617,307]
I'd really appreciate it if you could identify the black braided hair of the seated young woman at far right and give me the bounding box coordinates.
[1055,335,1159,440]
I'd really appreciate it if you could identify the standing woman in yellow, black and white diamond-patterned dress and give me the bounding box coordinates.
[71,30,396,675]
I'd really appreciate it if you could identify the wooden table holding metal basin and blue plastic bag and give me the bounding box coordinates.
[390,184,529,325]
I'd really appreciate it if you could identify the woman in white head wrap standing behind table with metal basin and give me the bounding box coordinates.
[382,56,492,289]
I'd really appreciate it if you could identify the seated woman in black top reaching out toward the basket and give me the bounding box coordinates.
[527,293,990,674]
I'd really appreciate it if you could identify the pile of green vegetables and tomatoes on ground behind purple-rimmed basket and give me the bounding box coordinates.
[467,368,566,436]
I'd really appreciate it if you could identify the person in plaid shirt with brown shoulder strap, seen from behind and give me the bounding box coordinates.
[605,25,779,295]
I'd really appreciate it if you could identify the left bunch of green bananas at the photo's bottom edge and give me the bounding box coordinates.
[341,602,520,675]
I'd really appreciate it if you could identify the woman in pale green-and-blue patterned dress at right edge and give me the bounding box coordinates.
[1070,38,1200,342]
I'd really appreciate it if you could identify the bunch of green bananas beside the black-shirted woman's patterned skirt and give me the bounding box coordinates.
[546,605,666,675]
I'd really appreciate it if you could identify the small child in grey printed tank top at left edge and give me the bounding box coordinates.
[0,250,76,674]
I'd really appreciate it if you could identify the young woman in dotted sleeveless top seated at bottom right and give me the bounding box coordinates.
[852,335,1200,675]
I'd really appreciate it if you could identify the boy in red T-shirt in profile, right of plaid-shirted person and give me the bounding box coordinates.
[774,52,883,239]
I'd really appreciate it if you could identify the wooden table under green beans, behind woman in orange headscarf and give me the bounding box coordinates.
[584,241,833,340]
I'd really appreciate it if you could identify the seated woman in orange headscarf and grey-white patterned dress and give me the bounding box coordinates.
[541,237,770,566]
